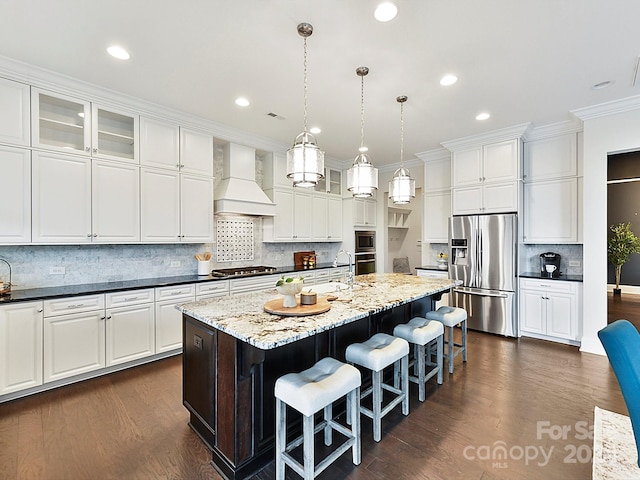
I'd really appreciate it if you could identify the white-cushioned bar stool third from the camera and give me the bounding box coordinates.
[393,317,444,402]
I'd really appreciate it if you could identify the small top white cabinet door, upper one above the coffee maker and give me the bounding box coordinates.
[523,133,578,182]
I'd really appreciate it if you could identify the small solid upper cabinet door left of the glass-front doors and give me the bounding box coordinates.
[0,78,31,147]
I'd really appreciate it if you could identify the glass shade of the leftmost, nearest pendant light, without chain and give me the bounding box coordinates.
[287,132,324,187]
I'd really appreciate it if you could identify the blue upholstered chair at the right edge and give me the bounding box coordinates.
[598,320,640,466]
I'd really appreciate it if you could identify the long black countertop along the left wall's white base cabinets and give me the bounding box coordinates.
[0,263,347,305]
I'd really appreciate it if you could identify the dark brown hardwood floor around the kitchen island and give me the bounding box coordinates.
[0,332,627,480]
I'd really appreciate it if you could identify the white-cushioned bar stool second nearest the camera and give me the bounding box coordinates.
[345,333,409,442]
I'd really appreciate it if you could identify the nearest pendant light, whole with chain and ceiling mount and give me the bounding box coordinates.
[287,23,324,187]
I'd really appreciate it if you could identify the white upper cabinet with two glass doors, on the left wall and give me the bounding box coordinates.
[31,89,139,163]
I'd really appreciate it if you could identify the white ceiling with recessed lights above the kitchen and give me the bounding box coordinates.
[0,0,640,166]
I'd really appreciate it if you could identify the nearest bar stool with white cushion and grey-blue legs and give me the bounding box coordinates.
[275,357,361,480]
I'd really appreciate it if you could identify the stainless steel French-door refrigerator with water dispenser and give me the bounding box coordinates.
[449,214,518,337]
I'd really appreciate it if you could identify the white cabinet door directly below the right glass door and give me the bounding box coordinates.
[91,159,140,243]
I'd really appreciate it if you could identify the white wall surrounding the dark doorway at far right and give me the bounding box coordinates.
[574,102,640,355]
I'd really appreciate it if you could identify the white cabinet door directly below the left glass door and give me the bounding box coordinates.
[32,151,91,243]
